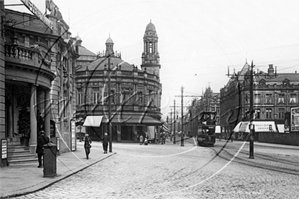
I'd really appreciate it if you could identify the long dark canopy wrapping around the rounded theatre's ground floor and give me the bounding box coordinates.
[102,113,163,126]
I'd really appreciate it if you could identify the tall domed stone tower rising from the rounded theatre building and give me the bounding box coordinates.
[141,21,160,76]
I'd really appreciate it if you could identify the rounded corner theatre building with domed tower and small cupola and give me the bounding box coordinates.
[76,22,162,141]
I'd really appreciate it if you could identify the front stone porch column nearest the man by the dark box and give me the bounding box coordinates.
[30,84,37,153]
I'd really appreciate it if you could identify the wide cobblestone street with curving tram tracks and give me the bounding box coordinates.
[10,141,299,199]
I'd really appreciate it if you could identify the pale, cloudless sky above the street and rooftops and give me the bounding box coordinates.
[5,0,299,118]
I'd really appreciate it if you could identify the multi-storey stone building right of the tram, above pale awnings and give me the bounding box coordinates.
[220,63,299,139]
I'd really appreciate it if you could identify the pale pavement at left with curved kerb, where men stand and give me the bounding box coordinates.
[0,142,116,198]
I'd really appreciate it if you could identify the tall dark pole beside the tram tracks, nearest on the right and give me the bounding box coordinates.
[249,61,255,159]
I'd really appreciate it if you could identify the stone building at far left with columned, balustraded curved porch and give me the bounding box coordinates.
[0,1,78,166]
